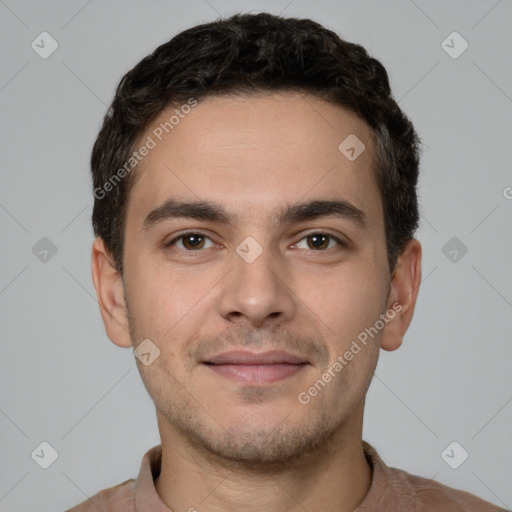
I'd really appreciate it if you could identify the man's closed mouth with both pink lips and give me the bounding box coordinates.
[202,350,309,384]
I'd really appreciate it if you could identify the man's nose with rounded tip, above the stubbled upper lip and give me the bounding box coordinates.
[220,239,297,327]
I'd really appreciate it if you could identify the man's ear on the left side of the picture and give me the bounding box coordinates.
[91,237,132,348]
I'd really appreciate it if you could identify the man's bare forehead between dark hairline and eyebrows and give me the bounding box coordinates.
[128,93,382,233]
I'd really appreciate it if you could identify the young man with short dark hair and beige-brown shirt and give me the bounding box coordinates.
[71,13,508,512]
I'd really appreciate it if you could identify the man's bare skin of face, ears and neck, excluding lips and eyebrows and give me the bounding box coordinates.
[92,93,421,512]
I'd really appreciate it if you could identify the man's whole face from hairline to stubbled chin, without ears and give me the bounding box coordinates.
[104,93,406,464]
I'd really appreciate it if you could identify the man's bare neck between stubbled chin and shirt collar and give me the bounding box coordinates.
[155,408,372,512]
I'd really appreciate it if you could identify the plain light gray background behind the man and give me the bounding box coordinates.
[0,0,512,512]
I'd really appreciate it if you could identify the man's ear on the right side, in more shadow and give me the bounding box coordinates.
[381,238,421,351]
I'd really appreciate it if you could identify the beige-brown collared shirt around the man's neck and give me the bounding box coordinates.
[66,441,505,512]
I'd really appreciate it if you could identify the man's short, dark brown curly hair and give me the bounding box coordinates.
[91,13,420,275]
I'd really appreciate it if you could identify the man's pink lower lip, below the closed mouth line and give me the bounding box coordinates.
[206,363,307,384]
